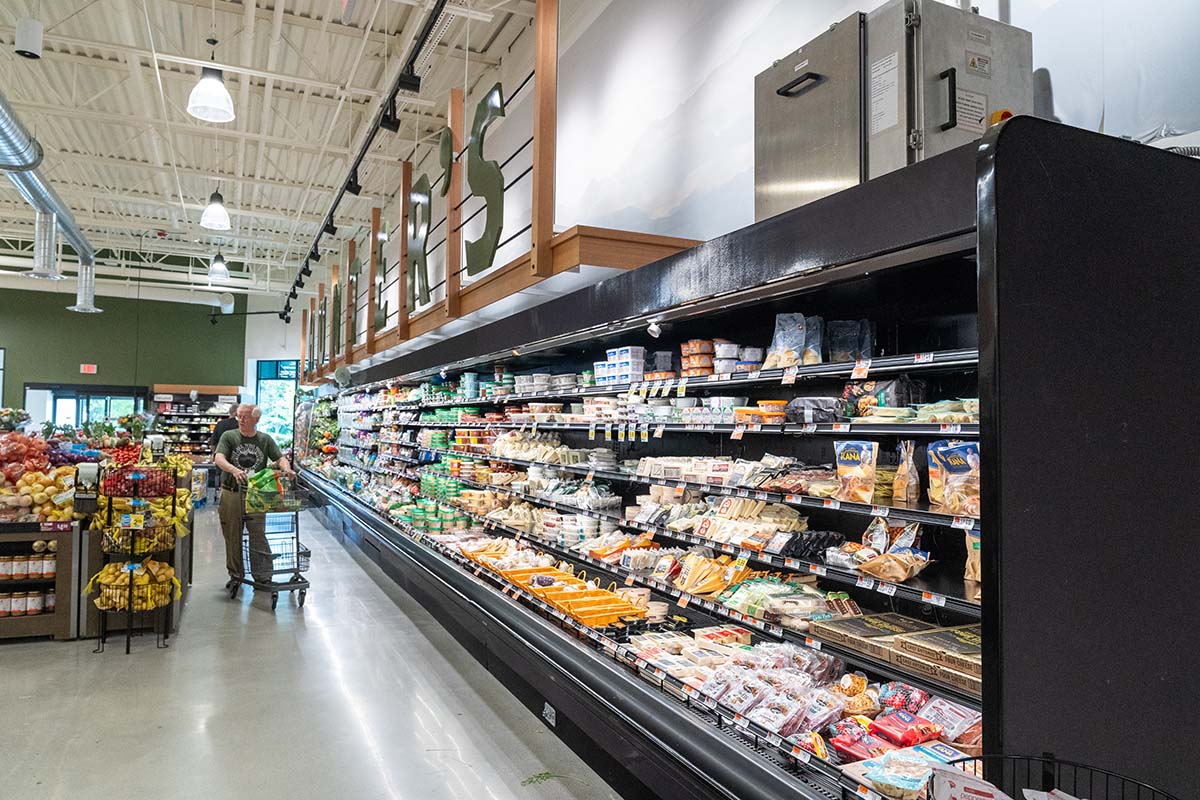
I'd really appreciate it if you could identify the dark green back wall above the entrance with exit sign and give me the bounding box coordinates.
[0,289,246,408]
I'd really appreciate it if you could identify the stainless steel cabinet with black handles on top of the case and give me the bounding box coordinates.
[755,0,1033,219]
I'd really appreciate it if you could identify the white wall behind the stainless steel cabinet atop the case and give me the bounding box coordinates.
[554,0,1200,244]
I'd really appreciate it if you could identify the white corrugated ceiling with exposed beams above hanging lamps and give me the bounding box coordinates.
[0,0,534,302]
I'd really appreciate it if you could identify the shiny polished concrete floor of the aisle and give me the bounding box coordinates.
[0,510,617,800]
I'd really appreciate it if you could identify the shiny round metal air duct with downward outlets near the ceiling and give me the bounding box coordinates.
[0,94,96,306]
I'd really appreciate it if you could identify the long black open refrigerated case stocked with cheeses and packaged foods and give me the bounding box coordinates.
[297,118,1200,800]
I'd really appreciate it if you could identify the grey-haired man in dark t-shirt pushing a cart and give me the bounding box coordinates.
[215,403,296,588]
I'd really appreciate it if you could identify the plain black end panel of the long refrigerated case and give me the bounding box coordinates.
[977,118,1200,796]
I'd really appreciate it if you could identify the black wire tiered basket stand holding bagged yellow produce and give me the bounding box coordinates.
[89,465,180,655]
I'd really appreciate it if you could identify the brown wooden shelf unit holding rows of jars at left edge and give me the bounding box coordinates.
[0,522,79,639]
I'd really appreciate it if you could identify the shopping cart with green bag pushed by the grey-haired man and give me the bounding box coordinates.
[229,475,312,610]
